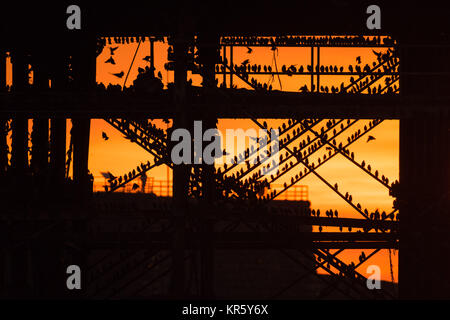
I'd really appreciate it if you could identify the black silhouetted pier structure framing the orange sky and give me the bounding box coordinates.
[0,1,450,298]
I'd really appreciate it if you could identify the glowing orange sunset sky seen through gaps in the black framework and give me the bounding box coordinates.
[5,37,399,282]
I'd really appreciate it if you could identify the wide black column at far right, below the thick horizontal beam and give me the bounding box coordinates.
[399,106,450,299]
